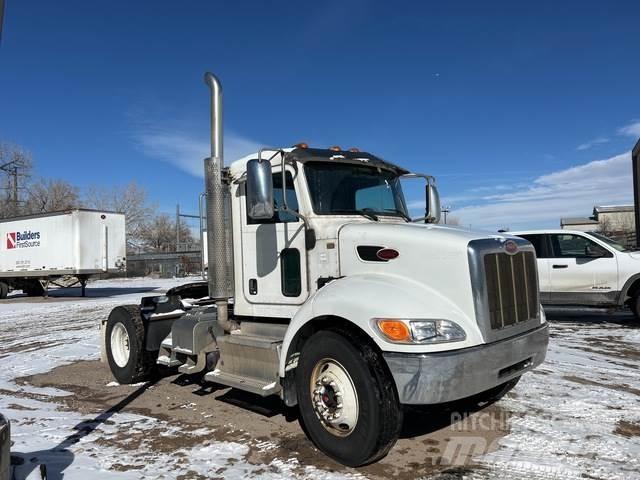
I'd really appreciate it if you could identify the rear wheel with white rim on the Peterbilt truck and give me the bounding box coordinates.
[105,305,157,384]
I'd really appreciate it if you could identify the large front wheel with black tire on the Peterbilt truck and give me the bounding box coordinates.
[296,331,402,467]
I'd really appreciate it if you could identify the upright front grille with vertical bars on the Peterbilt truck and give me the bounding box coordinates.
[484,251,539,330]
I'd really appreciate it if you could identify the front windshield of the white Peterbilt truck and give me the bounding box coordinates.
[304,162,408,219]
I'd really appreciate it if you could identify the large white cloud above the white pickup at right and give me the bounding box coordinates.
[452,153,633,230]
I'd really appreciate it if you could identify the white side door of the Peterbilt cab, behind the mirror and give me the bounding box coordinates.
[241,169,309,305]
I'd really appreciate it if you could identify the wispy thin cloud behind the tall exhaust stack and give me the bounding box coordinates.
[134,128,261,177]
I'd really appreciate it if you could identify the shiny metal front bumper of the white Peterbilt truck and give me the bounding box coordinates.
[383,324,549,405]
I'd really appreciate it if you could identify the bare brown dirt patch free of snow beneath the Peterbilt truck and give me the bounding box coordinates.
[17,361,509,479]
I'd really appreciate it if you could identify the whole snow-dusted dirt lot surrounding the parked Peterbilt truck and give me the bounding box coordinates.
[0,279,640,480]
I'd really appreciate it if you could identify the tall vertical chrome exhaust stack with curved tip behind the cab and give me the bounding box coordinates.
[204,72,237,332]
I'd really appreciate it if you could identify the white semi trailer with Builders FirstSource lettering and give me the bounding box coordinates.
[0,209,126,298]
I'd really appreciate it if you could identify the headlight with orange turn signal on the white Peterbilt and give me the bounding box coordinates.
[374,318,467,344]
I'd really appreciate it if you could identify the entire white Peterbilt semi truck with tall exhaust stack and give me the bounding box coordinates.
[102,73,548,466]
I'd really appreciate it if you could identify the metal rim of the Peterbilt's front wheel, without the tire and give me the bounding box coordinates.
[310,358,359,437]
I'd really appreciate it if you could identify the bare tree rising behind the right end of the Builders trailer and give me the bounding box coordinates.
[84,182,156,249]
